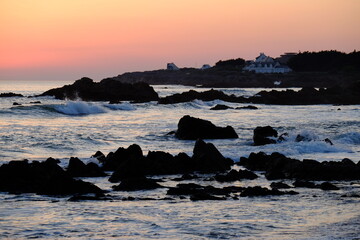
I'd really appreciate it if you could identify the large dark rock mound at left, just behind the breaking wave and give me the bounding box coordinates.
[39,78,159,102]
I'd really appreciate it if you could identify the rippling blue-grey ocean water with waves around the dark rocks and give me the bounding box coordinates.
[0,81,360,239]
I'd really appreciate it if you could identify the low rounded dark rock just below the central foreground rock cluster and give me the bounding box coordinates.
[112,176,163,191]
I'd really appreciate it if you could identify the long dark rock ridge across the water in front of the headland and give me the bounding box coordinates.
[27,78,360,105]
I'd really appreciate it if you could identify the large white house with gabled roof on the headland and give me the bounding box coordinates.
[243,53,291,73]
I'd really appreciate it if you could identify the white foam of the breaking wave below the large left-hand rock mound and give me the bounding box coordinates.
[55,101,106,115]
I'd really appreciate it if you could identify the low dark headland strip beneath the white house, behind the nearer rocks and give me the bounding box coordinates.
[107,68,360,88]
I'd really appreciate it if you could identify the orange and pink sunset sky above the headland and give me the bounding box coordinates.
[0,0,360,81]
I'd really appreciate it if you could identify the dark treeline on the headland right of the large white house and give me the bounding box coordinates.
[288,51,360,72]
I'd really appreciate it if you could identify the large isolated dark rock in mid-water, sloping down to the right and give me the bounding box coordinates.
[175,115,238,140]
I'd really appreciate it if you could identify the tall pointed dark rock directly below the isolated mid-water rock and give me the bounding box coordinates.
[192,139,234,173]
